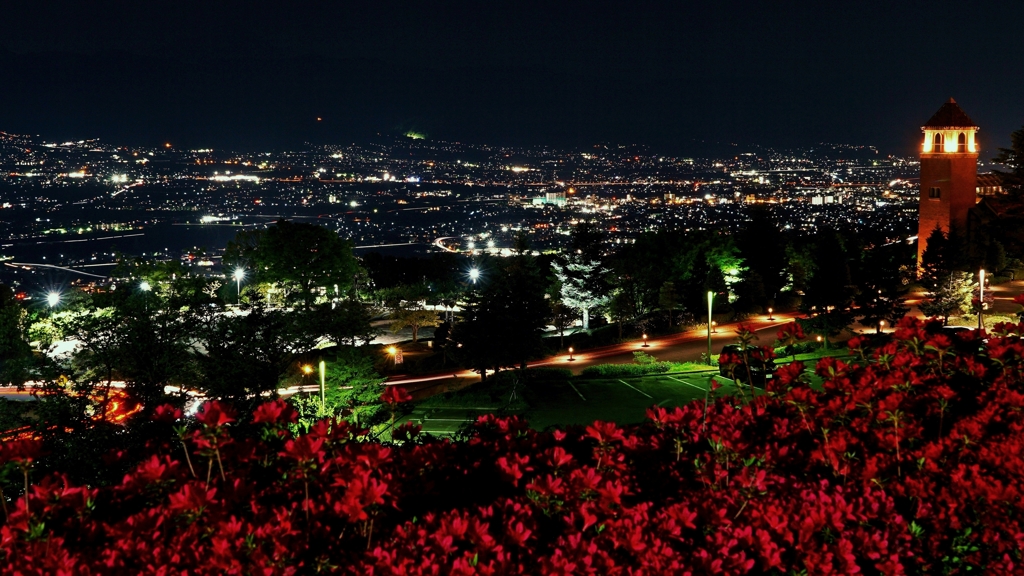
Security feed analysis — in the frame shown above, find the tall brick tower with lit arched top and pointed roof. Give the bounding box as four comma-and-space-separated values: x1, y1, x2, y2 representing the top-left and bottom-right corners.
918, 98, 978, 268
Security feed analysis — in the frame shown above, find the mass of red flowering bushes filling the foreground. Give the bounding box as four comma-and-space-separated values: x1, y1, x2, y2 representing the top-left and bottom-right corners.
0, 319, 1024, 575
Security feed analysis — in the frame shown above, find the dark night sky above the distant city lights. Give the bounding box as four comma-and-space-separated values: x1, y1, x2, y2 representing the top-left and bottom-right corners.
0, 0, 1024, 156
